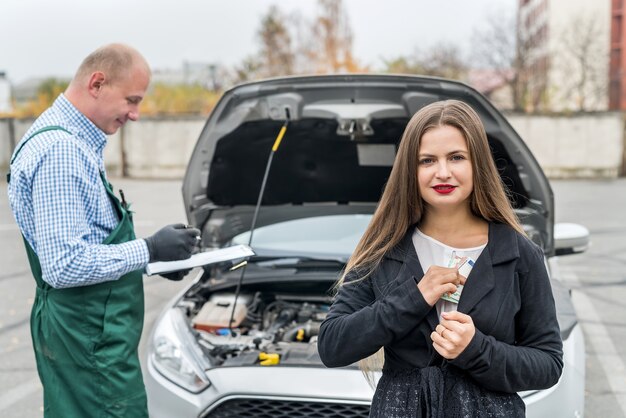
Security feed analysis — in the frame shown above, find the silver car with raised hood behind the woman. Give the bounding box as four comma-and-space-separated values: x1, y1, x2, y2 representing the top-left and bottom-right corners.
145, 75, 588, 418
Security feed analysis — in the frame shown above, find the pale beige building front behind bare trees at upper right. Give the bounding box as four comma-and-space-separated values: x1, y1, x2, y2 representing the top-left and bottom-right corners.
518, 0, 608, 112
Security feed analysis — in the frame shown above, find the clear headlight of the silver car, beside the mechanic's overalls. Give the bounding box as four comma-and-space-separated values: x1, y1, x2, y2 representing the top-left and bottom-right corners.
150, 308, 211, 393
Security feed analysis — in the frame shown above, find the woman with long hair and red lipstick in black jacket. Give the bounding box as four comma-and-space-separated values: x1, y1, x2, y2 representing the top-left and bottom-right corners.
318, 100, 563, 418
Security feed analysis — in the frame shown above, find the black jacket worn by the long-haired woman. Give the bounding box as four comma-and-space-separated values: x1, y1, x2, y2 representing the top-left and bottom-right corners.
318, 223, 563, 393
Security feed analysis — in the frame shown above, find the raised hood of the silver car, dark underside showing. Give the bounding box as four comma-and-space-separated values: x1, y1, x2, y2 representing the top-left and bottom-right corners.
183, 75, 554, 254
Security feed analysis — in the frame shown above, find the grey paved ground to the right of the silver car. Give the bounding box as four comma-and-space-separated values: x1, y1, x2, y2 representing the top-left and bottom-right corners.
553, 179, 626, 418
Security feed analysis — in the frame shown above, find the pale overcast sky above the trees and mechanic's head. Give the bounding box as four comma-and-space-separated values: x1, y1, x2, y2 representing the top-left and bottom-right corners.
0, 0, 517, 84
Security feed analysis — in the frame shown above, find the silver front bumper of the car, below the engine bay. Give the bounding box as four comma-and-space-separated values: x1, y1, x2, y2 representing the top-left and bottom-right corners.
145, 325, 585, 418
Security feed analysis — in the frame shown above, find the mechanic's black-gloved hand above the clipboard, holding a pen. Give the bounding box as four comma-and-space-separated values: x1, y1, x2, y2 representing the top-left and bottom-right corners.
145, 224, 200, 263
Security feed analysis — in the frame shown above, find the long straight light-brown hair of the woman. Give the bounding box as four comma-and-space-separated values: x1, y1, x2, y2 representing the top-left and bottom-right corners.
337, 100, 524, 383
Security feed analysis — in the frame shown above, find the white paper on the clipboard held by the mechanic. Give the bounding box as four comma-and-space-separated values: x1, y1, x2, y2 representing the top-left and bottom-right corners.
146, 244, 254, 276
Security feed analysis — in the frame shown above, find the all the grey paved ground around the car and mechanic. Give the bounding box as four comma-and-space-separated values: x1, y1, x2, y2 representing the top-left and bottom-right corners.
0, 179, 626, 418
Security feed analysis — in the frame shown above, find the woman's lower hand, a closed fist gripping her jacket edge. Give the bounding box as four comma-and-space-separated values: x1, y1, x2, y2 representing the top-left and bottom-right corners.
430, 311, 476, 360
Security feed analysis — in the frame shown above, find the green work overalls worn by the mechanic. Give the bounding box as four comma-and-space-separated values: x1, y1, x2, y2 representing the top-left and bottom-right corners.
14, 126, 148, 418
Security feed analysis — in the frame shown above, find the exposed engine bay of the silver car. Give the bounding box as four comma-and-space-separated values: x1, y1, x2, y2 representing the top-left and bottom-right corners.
177, 289, 331, 367
